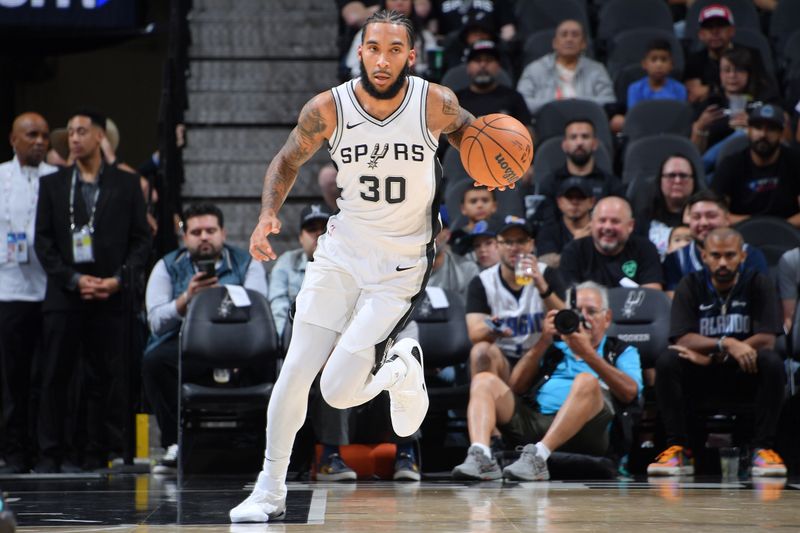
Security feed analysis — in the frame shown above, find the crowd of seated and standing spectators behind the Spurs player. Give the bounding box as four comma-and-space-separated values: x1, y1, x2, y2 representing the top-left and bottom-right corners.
0, 0, 800, 480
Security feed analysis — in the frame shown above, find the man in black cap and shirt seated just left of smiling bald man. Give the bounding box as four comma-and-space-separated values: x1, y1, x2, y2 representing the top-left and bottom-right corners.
536, 177, 596, 268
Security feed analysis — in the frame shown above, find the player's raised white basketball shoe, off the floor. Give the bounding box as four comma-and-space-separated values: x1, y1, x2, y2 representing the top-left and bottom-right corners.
387, 338, 429, 437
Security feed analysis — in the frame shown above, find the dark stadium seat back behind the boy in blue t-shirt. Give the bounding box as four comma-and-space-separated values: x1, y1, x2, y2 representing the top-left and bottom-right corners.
606, 28, 684, 80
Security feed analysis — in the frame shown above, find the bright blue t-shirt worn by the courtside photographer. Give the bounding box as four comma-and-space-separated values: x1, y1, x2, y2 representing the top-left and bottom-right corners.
536, 337, 643, 415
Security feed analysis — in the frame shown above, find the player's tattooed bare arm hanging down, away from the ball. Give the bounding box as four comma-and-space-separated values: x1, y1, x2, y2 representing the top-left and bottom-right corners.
261, 100, 326, 213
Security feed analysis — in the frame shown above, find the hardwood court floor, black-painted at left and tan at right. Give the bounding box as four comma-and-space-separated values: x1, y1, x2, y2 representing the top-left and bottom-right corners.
0, 475, 800, 533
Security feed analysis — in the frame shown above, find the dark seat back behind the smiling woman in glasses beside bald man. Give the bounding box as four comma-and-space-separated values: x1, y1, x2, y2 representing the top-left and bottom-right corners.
622, 133, 706, 183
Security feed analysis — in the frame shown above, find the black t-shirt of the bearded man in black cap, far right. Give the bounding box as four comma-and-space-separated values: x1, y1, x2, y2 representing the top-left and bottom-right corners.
712, 146, 800, 218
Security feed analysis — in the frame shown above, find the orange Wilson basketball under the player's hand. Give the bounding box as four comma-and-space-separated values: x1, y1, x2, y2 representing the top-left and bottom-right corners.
461, 113, 533, 187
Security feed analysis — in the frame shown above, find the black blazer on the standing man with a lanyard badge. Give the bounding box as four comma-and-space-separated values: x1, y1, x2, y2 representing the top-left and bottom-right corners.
34, 166, 151, 311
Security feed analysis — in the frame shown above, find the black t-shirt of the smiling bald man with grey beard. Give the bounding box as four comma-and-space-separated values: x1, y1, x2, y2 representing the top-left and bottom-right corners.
559, 234, 664, 287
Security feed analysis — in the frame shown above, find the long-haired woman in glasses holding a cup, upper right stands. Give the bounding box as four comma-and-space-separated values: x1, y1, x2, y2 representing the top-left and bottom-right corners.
692, 48, 776, 170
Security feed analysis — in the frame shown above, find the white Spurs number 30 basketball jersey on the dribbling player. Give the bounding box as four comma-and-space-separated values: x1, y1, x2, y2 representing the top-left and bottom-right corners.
328, 76, 441, 255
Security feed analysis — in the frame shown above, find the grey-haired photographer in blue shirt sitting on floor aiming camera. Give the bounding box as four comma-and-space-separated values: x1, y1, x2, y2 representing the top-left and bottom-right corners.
453, 282, 642, 481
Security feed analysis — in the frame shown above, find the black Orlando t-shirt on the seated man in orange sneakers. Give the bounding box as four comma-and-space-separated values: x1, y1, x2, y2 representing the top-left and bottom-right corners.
669, 269, 783, 342
